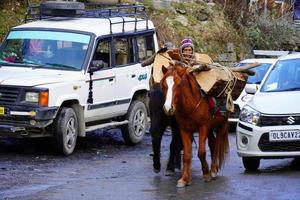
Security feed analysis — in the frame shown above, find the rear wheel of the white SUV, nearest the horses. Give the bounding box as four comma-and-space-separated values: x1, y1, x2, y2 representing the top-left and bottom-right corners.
121, 100, 147, 145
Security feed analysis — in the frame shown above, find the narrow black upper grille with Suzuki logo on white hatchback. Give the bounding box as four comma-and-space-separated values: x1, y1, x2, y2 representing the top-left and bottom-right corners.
259, 115, 300, 126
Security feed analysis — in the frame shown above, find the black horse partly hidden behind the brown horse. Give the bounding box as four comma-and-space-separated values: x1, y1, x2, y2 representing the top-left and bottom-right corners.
148, 84, 182, 176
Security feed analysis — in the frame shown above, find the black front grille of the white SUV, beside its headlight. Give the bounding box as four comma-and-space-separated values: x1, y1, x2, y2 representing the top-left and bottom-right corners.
0, 86, 20, 105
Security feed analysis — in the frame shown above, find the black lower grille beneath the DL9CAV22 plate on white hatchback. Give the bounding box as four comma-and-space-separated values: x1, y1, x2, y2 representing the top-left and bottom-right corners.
258, 133, 300, 152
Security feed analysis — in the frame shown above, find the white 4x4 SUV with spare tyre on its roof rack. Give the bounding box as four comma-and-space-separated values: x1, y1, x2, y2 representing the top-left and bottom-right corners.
0, 1, 158, 155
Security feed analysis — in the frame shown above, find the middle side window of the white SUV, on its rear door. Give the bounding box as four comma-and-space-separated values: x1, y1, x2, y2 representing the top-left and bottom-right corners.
114, 38, 134, 66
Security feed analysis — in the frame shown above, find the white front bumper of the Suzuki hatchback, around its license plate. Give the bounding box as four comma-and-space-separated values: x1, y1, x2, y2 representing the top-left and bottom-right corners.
236, 122, 300, 158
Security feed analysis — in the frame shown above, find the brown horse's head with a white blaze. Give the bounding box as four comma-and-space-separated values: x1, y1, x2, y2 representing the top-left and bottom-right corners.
160, 64, 187, 115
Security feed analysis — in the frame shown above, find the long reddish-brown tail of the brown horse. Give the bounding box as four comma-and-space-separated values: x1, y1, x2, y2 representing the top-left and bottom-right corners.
215, 121, 229, 168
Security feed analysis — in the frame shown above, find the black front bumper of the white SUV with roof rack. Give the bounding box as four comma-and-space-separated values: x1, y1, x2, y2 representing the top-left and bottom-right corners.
0, 106, 58, 137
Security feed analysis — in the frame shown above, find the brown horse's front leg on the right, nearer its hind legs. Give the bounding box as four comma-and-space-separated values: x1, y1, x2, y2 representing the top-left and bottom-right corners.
198, 125, 210, 182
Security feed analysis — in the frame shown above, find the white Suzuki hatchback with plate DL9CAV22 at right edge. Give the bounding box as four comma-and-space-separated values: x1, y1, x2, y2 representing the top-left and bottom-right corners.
236, 54, 300, 170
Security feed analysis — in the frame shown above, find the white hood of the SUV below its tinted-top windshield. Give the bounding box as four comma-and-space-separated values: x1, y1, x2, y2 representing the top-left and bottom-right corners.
0, 67, 81, 86
